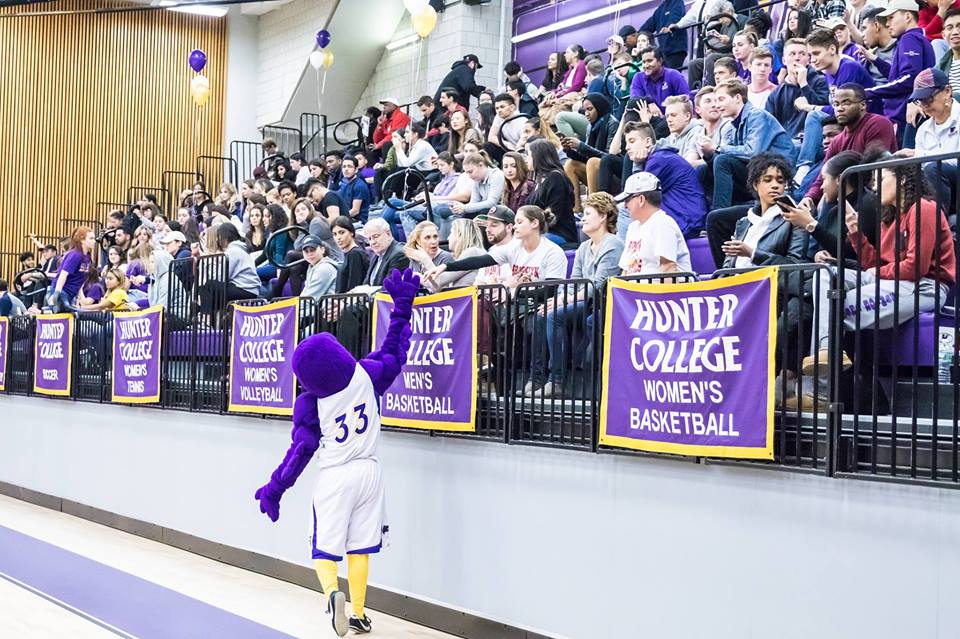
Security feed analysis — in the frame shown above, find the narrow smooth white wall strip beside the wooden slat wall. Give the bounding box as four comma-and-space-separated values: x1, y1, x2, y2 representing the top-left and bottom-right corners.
223, 6, 260, 151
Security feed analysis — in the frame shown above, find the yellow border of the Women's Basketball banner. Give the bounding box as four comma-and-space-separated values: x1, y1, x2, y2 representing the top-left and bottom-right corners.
598, 266, 780, 460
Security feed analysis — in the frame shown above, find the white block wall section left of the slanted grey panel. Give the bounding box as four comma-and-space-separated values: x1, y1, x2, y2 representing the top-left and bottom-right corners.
256, 0, 337, 127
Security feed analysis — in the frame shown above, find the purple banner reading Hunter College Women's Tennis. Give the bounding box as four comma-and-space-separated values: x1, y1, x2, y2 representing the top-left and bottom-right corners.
113, 306, 163, 404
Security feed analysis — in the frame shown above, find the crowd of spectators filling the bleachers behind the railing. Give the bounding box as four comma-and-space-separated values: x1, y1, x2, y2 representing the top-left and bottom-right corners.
7, 0, 960, 406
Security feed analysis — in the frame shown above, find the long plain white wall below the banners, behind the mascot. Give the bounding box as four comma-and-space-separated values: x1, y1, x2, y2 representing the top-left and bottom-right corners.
0, 396, 960, 639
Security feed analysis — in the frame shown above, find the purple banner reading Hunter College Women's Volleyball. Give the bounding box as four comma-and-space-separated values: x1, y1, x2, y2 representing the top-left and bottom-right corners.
228, 298, 300, 415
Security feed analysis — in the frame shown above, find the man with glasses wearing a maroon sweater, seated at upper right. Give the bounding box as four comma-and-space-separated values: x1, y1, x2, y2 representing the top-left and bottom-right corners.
800, 83, 897, 211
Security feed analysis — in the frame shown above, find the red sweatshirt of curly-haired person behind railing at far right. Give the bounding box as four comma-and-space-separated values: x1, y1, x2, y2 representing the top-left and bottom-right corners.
848, 200, 957, 286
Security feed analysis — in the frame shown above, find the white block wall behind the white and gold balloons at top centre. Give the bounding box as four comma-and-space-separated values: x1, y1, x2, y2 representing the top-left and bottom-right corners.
354, 0, 513, 119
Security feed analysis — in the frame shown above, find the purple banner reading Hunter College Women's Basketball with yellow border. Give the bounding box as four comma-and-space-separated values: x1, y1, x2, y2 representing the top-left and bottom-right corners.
600, 268, 777, 459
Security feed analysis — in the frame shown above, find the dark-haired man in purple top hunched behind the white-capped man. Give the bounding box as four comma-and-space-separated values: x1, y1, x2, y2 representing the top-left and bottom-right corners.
619, 122, 707, 239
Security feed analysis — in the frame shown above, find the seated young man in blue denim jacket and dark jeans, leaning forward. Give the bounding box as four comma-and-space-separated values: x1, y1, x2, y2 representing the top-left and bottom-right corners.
700, 80, 793, 209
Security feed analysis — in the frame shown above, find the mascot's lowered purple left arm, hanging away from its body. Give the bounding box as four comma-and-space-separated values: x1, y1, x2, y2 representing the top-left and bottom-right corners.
254, 393, 320, 521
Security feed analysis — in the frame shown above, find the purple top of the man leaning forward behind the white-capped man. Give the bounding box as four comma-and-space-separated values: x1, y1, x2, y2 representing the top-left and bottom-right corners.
634, 147, 707, 238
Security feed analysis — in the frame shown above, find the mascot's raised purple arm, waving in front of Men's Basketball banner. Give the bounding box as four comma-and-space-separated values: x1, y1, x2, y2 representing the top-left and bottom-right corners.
360, 269, 420, 395
